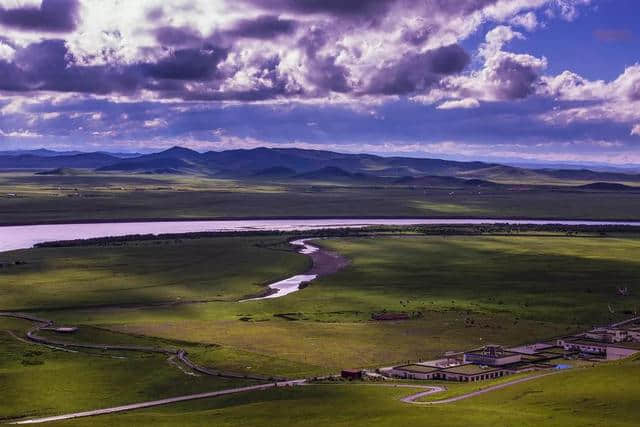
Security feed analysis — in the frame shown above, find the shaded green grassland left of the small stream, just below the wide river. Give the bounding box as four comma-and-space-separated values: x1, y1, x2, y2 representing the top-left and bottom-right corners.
0, 237, 309, 311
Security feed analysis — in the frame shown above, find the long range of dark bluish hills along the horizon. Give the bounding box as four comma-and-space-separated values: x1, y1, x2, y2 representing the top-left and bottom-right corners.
0, 147, 640, 185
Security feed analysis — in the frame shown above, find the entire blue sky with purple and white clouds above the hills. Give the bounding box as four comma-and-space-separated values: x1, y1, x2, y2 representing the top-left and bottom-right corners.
0, 0, 640, 165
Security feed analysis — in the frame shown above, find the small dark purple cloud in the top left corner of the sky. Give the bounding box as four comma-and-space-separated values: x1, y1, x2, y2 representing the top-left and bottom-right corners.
0, 0, 78, 32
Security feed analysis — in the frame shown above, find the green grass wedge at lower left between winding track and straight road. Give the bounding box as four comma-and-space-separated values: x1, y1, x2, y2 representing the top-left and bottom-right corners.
0, 318, 248, 422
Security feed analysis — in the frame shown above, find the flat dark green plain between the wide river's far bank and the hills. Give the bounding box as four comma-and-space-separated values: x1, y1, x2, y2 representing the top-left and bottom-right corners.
0, 172, 640, 224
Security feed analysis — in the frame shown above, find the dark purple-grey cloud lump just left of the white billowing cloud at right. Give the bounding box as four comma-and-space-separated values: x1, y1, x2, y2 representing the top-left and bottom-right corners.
367, 44, 470, 95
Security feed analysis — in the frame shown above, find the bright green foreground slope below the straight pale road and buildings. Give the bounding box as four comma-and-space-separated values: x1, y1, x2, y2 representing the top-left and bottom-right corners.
51, 361, 640, 427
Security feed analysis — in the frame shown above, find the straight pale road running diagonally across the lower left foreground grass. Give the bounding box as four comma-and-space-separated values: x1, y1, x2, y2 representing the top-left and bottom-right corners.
11, 380, 305, 424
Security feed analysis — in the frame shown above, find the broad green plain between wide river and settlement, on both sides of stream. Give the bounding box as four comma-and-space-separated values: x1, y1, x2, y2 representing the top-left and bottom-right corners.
0, 236, 640, 376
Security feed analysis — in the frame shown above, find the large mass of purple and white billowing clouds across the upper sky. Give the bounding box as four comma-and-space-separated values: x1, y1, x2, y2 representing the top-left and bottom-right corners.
0, 0, 582, 105
